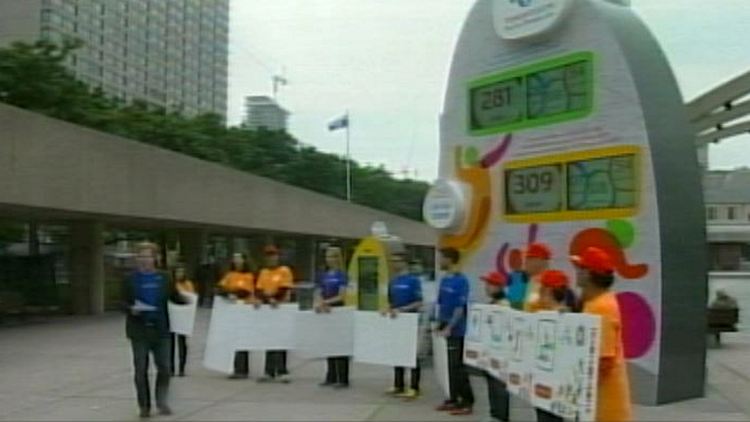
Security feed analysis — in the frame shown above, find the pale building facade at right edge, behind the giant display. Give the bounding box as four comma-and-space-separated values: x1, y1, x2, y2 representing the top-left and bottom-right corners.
704, 168, 750, 271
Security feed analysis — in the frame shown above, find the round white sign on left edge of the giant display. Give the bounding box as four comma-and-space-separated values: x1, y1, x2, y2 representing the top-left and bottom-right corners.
422, 179, 466, 230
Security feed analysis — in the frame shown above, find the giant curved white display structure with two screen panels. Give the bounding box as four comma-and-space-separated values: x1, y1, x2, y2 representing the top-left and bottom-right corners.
424, 0, 706, 404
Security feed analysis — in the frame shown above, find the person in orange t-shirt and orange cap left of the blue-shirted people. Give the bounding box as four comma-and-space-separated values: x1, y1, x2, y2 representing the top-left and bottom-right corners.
255, 245, 294, 383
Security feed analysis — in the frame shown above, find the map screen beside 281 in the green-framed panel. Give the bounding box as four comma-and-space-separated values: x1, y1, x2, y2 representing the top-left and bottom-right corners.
526, 61, 591, 119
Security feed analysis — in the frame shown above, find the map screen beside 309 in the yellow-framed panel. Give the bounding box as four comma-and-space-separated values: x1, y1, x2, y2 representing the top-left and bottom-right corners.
567, 155, 638, 211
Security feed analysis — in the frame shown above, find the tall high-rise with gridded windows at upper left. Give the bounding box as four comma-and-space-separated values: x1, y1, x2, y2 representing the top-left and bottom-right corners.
0, 0, 229, 116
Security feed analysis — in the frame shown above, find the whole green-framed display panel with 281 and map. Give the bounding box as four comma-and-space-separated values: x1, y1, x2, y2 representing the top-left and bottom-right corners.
468, 52, 594, 135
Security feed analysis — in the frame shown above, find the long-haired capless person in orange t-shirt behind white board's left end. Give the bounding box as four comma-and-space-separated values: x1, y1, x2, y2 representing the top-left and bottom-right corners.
219, 253, 255, 379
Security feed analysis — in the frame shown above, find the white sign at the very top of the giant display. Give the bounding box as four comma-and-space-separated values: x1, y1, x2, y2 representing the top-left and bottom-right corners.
492, 0, 575, 40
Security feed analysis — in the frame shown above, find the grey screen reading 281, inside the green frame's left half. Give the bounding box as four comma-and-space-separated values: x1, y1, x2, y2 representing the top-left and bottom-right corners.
471, 77, 526, 130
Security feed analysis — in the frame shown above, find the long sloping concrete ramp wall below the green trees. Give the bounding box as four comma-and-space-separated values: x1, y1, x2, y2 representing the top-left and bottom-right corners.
0, 105, 435, 245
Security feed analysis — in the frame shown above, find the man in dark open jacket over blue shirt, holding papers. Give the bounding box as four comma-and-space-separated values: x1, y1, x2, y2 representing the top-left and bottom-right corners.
122, 243, 188, 418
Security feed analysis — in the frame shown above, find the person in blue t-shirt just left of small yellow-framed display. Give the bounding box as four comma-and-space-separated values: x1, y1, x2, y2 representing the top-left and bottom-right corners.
315, 246, 349, 389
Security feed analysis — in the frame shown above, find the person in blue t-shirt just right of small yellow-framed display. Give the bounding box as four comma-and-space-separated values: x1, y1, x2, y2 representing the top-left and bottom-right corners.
385, 253, 422, 400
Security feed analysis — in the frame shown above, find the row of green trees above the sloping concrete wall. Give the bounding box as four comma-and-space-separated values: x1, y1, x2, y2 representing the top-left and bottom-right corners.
0, 40, 428, 220
